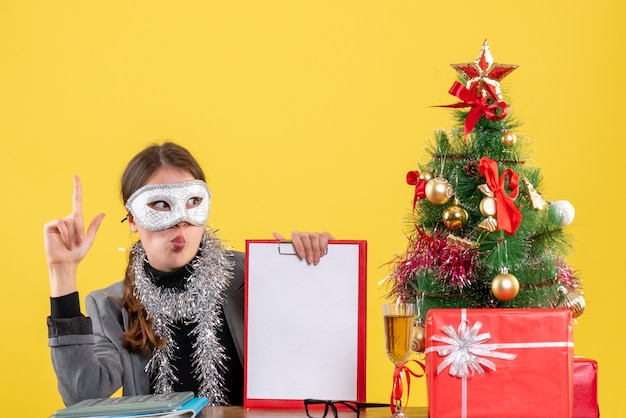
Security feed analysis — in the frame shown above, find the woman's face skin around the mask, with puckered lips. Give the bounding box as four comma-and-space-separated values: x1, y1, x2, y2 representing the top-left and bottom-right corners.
128, 166, 204, 271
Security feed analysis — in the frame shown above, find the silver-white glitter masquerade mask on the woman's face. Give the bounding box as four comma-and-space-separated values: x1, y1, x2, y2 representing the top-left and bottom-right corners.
126, 180, 211, 232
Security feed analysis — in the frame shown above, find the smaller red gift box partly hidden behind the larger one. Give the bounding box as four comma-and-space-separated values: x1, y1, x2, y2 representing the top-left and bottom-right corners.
572, 357, 600, 418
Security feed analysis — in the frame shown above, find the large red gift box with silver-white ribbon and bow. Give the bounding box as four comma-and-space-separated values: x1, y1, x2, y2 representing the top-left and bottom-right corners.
425, 309, 574, 418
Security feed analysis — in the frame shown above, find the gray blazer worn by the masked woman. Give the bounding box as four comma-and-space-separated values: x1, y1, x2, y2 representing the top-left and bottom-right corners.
48, 252, 245, 405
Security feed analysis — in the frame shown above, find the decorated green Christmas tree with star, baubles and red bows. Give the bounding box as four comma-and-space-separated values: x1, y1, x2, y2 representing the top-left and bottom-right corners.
388, 41, 585, 334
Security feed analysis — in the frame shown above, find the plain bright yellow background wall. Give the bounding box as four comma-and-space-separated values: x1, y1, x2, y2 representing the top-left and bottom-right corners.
0, 0, 626, 418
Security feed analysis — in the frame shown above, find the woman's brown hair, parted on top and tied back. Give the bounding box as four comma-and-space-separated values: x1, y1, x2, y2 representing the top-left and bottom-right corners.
121, 142, 205, 356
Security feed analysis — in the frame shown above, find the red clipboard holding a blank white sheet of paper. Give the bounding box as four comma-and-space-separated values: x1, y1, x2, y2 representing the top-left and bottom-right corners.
244, 240, 367, 409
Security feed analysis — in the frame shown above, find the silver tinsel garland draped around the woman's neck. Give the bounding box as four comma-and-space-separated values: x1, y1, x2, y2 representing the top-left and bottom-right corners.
131, 229, 233, 405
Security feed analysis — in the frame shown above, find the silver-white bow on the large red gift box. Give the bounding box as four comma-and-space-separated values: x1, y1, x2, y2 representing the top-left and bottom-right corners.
429, 320, 517, 378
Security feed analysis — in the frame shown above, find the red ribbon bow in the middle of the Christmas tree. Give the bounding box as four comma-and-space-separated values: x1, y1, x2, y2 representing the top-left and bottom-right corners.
479, 157, 522, 235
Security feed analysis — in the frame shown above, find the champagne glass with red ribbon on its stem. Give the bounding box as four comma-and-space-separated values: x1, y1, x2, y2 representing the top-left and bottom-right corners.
383, 303, 415, 418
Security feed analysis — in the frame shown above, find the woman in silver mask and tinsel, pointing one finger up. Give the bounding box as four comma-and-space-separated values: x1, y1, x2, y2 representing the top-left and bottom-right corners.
44, 142, 334, 405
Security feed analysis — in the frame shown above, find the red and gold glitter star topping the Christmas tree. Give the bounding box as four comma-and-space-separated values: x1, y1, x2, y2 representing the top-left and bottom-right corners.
451, 39, 518, 102
